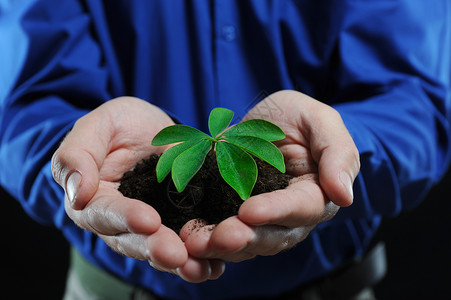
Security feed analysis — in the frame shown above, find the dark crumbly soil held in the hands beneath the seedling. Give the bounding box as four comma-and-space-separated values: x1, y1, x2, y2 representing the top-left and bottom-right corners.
119, 152, 292, 232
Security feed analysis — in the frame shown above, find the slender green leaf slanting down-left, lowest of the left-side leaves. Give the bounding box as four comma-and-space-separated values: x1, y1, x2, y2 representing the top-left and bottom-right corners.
171, 140, 212, 193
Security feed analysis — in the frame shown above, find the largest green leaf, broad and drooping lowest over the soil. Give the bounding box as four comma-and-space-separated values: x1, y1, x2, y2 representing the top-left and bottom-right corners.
216, 141, 257, 200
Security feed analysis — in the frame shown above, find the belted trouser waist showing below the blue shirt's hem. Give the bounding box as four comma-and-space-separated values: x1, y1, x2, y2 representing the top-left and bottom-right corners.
71, 242, 387, 300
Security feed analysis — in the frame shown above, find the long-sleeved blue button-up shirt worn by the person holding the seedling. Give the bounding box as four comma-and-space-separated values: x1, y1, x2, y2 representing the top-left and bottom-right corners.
0, 0, 451, 299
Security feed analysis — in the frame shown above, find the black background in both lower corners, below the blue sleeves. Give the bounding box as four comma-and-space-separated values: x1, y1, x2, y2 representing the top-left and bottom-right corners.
0, 173, 451, 300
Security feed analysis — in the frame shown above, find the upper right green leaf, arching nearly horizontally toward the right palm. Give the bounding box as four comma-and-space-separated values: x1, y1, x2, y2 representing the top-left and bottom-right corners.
224, 119, 285, 142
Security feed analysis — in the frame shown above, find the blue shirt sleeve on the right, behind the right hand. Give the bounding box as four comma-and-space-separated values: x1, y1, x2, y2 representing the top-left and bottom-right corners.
335, 1, 451, 221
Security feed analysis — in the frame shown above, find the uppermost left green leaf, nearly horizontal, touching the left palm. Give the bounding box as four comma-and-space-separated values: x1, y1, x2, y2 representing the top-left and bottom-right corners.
152, 124, 210, 146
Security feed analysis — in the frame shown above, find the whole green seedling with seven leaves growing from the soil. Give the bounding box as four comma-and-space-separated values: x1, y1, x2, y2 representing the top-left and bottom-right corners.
152, 107, 285, 200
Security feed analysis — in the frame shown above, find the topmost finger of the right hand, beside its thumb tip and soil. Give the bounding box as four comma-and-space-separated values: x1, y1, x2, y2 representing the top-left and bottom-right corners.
238, 175, 338, 228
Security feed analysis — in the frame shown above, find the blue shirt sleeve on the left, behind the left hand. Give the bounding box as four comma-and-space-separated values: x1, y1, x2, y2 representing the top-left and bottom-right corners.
0, 1, 107, 227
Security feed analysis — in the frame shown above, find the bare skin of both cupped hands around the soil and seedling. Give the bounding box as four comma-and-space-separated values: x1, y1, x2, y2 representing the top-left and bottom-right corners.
52, 91, 360, 282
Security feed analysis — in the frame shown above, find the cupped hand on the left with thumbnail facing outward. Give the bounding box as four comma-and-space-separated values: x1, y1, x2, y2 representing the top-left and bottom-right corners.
52, 97, 224, 282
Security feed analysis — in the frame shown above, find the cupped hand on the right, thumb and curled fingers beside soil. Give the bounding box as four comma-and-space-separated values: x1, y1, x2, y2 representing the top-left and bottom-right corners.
181, 91, 360, 262
